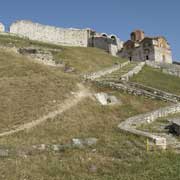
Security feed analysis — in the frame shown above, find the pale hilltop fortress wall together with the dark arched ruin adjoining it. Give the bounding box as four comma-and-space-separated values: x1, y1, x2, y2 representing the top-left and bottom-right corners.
10, 20, 123, 56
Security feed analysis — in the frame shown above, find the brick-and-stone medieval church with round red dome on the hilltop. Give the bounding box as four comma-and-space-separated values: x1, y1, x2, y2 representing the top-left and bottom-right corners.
118, 30, 172, 63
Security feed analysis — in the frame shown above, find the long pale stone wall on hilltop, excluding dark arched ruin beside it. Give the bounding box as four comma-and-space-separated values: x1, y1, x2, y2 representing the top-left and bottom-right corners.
10, 20, 90, 47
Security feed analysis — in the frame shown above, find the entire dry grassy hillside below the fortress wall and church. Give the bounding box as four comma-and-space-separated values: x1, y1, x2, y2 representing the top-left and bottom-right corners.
0, 35, 180, 180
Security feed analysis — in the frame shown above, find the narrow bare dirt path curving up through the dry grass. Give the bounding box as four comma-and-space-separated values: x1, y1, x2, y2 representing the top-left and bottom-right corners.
0, 84, 91, 137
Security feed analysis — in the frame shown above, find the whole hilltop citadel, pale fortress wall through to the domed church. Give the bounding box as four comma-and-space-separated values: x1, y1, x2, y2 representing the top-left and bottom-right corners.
0, 20, 172, 63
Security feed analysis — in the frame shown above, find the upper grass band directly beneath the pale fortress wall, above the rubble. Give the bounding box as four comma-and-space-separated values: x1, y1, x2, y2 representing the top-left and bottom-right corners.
0, 35, 125, 74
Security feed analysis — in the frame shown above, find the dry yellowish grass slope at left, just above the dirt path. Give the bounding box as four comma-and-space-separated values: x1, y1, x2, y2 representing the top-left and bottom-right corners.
0, 51, 78, 130
